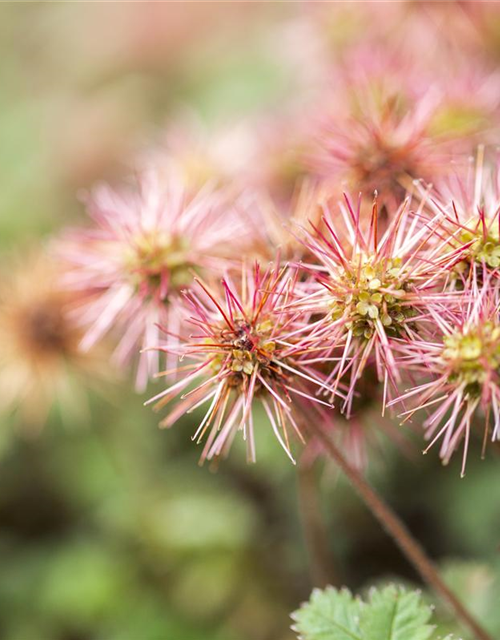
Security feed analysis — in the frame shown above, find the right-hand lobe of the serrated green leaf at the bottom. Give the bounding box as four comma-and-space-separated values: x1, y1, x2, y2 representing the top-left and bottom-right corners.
360, 585, 433, 640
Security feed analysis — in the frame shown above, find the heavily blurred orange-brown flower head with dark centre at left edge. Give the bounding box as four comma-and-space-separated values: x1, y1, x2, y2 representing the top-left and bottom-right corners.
0, 252, 112, 432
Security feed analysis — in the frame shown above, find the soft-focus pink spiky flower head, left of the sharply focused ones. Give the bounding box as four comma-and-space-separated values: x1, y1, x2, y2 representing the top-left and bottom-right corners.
58, 170, 244, 390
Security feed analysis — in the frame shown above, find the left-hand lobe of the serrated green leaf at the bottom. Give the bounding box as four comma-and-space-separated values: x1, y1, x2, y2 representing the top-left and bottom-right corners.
292, 587, 363, 640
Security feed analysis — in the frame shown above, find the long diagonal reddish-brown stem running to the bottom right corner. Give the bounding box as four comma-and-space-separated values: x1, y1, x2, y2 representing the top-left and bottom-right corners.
308, 420, 493, 640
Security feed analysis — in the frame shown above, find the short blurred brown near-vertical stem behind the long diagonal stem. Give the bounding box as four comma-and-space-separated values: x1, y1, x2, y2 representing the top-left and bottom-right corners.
297, 459, 338, 587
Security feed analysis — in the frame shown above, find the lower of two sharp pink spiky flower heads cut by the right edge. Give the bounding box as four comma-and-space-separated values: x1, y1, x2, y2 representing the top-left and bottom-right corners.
395, 272, 500, 475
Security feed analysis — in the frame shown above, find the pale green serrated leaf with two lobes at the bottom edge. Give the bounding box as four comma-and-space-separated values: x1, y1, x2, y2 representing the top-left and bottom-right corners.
292, 585, 434, 640
